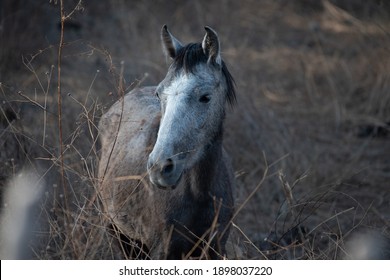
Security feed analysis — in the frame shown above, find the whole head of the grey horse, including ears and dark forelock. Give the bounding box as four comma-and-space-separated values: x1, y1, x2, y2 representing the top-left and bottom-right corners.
147, 26, 227, 188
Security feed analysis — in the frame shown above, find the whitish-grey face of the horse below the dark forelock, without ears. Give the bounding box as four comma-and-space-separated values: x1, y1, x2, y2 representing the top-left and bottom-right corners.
148, 64, 225, 187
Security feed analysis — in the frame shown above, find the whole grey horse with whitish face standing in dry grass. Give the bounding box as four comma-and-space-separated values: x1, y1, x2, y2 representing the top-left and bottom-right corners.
98, 25, 236, 259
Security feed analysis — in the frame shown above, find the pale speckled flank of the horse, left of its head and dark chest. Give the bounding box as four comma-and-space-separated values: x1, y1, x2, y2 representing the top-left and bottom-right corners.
98, 87, 160, 243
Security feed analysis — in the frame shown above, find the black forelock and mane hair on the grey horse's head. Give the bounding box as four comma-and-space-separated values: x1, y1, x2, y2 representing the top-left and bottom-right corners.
172, 43, 236, 106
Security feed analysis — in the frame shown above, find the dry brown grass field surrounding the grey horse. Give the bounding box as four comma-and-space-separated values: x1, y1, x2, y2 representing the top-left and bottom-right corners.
0, 0, 390, 259
